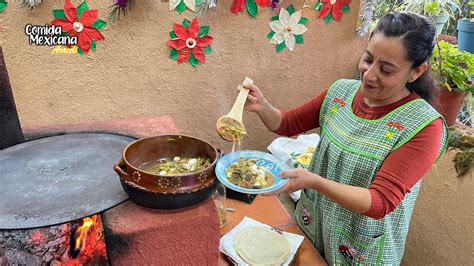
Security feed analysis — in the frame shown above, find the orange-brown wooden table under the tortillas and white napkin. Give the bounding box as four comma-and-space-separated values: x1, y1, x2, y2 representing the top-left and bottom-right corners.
219, 195, 327, 266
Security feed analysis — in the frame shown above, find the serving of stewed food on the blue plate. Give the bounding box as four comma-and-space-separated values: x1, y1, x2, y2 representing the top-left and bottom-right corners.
226, 158, 275, 189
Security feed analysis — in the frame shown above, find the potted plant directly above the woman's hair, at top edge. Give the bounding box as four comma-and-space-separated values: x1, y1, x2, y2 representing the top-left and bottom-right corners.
397, 0, 459, 35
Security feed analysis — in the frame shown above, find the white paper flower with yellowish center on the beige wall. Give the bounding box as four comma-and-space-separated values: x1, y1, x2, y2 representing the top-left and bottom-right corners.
268, 8, 308, 51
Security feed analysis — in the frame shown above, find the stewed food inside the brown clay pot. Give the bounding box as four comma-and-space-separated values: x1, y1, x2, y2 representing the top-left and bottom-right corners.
139, 157, 211, 176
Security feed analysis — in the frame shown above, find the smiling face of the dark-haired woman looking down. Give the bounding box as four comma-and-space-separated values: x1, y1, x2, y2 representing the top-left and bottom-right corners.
359, 33, 414, 106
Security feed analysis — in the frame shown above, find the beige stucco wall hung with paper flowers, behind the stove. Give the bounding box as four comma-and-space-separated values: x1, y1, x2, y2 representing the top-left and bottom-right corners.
0, 0, 366, 149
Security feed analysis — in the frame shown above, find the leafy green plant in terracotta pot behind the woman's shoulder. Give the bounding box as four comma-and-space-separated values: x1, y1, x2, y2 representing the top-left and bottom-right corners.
430, 41, 474, 125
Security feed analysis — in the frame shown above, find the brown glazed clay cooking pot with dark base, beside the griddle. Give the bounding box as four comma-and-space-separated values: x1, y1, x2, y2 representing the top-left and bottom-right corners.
114, 135, 219, 209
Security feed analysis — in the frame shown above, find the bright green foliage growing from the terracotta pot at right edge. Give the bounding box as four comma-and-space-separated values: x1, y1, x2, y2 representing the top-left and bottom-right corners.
430, 41, 474, 92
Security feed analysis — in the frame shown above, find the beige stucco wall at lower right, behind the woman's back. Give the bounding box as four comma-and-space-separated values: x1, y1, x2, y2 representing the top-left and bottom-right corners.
403, 151, 474, 265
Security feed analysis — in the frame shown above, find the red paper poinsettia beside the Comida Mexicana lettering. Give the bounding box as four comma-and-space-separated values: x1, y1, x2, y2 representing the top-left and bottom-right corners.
49, 0, 105, 54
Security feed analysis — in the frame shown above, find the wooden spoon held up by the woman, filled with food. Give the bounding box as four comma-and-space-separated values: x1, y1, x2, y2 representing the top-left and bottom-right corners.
216, 77, 253, 142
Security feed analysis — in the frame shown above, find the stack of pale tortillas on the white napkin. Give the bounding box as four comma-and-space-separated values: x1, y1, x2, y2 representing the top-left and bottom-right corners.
234, 227, 291, 265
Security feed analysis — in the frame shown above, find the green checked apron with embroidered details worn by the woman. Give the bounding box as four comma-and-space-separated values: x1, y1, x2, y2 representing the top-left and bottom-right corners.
295, 80, 448, 265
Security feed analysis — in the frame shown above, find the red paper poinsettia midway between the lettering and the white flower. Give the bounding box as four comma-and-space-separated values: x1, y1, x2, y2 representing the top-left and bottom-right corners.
166, 19, 212, 66
